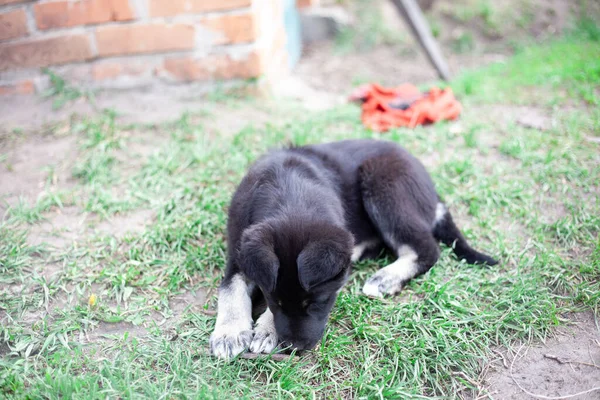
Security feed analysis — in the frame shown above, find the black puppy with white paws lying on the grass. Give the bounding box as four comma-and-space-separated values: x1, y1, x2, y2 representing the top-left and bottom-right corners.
210, 140, 496, 358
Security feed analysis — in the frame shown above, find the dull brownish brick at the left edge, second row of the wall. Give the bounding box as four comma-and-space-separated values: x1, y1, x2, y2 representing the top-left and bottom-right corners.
0, 34, 93, 71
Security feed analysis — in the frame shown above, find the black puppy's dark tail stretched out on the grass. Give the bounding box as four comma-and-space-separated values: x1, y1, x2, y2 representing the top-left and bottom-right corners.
433, 208, 498, 265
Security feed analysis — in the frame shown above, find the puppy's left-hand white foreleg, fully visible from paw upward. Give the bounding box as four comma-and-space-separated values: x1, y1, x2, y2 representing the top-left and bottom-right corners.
209, 275, 252, 360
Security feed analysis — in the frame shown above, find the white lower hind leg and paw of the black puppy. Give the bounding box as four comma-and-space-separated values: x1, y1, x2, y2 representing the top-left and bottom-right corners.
363, 245, 419, 297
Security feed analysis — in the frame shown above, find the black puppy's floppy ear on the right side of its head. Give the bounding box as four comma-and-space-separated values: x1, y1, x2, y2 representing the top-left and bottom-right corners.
296, 231, 352, 292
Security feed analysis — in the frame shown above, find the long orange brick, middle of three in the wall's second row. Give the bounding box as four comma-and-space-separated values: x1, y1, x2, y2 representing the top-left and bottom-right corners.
96, 24, 194, 57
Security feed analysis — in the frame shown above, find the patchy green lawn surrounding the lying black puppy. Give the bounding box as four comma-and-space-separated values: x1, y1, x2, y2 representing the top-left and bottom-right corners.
0, 31, 600, 399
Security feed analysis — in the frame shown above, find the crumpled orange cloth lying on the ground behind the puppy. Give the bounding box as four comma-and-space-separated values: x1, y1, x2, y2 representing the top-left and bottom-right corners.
350, 83, 462, 132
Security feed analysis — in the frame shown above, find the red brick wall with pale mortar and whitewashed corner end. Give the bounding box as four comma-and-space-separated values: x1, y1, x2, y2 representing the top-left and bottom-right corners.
0, 0, 287, 94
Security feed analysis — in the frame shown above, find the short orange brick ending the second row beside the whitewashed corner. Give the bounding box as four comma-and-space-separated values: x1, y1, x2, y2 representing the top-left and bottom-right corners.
201, 14, 257, 44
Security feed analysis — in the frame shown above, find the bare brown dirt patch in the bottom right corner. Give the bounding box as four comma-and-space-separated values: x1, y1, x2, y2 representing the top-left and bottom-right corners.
485, 312, 600, 400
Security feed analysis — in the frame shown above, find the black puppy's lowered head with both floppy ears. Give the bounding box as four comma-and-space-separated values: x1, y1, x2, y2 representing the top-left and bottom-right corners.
240, 220, 353, 350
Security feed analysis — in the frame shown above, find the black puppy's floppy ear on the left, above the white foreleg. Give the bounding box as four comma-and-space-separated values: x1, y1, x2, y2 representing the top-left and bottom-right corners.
239, 224, 279, 292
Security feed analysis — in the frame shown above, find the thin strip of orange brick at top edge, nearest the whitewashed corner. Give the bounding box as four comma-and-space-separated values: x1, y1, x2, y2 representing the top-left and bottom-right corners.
149, 0, 252, 17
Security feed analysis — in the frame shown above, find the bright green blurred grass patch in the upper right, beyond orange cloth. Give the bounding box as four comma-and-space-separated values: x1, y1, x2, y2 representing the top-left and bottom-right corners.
452, 20, 600, 106
